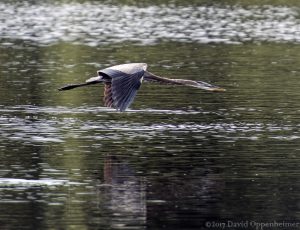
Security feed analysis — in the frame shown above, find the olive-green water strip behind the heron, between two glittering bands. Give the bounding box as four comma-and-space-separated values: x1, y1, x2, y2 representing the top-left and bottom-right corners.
0, 40, 299, 118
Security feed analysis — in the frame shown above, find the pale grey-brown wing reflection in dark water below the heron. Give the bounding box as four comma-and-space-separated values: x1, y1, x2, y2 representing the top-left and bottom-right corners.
98, 155, 146, 227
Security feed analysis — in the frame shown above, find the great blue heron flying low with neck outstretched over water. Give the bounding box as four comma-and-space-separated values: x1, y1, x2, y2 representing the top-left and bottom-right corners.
59, 63, 225, 111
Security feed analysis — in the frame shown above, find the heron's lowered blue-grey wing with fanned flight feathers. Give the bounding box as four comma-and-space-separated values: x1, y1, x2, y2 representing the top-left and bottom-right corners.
101, 69, 144, 111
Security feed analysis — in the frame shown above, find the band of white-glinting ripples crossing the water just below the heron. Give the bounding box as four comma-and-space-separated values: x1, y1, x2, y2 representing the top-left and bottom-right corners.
0, 105, 300, 144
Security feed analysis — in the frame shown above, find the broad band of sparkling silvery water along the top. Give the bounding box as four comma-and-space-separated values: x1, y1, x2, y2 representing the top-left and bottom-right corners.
0, 2, 300, 46
